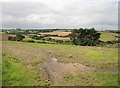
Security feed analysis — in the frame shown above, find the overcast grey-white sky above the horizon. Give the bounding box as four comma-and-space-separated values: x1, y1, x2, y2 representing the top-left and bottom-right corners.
0, 0, 119, 29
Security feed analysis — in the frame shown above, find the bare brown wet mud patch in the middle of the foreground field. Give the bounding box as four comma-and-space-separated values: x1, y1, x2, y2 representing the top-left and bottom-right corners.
43, 58, 94, 84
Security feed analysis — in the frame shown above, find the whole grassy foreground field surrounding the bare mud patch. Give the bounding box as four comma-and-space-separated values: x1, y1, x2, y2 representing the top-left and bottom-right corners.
2, 41, 118, 86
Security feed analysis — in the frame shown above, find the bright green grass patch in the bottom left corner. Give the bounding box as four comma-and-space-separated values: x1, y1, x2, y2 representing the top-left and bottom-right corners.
2, 55, 36, 86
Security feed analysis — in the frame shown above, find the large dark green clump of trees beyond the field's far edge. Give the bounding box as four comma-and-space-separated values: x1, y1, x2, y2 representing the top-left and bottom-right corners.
70, 28, 101, 46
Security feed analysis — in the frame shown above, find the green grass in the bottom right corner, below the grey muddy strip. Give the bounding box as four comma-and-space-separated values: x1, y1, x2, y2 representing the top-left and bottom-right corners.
90, 72, 118, 86
